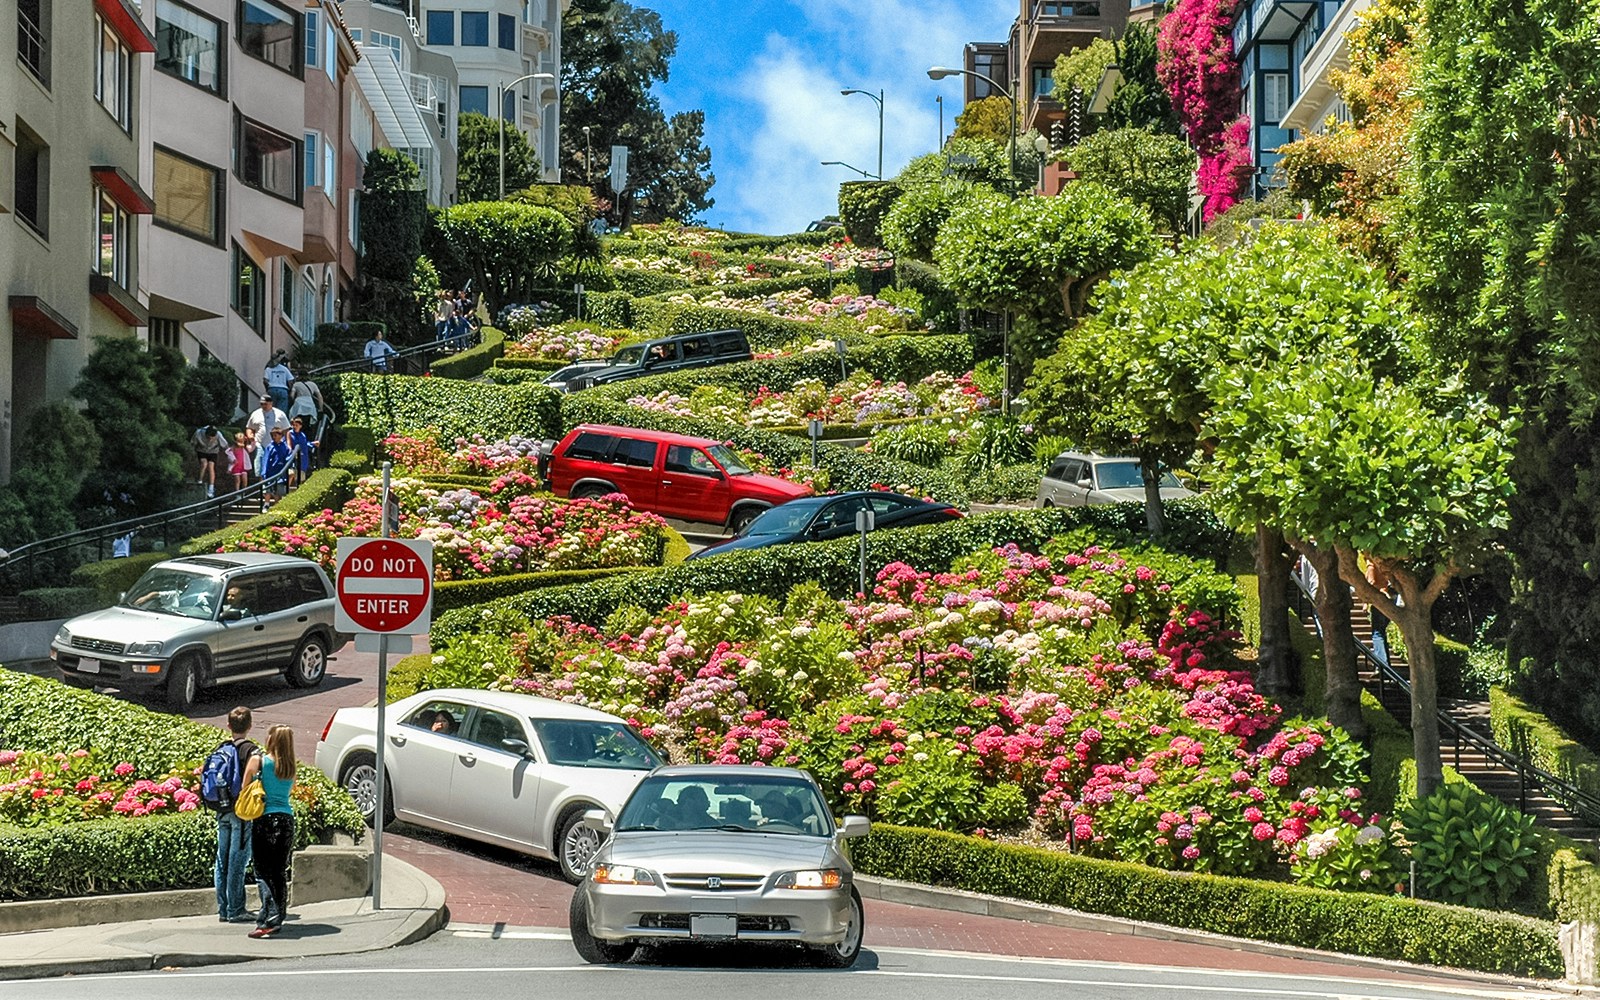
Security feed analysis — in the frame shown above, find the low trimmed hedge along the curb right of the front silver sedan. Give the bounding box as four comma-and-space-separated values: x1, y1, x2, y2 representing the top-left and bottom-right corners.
851, 826, 1565, 978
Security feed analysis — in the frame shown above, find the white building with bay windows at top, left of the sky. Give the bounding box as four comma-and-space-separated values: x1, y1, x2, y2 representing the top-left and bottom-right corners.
418, 0, 571, 182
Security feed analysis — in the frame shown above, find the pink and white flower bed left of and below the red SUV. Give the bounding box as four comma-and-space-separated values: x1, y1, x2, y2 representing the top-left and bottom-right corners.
222, 472, 666, 581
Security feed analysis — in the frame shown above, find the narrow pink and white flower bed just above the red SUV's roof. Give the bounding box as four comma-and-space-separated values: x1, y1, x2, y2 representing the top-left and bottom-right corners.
627, 371, 992, 427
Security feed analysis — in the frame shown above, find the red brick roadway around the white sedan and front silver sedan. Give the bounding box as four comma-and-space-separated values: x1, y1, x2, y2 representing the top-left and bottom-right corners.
190, 646, 1491, 986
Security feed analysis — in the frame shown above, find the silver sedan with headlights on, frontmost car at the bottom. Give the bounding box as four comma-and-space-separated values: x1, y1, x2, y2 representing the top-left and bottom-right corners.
571, 765, 869, 968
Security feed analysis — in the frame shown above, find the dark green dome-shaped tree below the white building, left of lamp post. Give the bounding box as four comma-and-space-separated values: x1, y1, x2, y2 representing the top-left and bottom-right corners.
437, 202, 573, 314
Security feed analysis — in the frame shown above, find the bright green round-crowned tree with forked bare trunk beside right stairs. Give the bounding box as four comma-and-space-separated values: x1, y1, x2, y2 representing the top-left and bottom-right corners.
1211, 354, 1515, 798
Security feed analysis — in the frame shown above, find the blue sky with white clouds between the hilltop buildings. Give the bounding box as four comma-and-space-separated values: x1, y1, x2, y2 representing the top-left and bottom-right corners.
634, 0, 1018, 234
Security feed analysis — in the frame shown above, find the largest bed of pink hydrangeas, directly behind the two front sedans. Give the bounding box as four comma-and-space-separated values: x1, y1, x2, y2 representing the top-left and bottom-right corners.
419, 546, 1392, 890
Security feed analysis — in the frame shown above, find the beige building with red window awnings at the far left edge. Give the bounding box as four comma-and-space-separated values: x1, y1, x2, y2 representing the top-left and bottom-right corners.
0, 0, 155, 480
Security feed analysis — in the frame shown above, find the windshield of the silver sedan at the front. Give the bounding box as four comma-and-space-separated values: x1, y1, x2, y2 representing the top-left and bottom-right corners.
616, 774, 834, 837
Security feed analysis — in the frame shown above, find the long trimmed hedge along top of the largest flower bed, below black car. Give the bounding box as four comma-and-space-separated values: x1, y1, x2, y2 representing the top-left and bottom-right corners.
430, 502, 1214, 650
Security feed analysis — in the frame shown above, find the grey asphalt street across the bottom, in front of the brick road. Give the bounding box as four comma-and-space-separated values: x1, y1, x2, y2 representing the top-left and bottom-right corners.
0, 930, 1558, 1000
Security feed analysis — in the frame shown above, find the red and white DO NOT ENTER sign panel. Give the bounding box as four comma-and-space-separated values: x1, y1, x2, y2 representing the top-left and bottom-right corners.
333, 538, 434, 635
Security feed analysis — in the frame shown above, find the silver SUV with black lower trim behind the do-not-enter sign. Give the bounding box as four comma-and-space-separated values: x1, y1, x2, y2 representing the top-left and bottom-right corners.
50, 552, 349, 710
